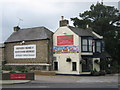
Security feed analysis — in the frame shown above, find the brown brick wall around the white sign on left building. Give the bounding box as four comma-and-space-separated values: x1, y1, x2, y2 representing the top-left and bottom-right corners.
5, 40, 52, 63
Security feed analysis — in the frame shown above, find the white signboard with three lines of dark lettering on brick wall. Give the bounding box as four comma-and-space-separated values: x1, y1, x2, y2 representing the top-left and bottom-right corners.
14, 45, 36, 59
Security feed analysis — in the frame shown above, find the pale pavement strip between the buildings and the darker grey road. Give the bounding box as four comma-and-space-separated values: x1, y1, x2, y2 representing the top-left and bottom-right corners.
0, 74, 118, 85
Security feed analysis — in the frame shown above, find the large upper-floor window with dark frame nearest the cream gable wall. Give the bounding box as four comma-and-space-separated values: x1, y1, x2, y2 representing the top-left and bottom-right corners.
82, 37, 92, 52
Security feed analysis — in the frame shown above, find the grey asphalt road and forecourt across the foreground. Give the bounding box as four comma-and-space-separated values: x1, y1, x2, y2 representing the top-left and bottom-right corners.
2, 75, 119, 88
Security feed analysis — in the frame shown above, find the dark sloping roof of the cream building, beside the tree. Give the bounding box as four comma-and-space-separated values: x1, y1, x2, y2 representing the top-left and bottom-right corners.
68, 26, 98, 39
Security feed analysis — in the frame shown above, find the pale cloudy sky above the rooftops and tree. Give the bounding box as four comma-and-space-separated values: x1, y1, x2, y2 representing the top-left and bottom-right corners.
0, 0, 119, 43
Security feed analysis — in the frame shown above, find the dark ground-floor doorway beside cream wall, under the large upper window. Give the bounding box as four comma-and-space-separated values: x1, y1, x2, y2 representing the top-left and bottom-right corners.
82, 57, 92, 72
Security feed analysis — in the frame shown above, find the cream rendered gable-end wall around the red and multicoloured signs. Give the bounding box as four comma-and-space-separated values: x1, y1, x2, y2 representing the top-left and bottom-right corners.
53, 26, 80, 74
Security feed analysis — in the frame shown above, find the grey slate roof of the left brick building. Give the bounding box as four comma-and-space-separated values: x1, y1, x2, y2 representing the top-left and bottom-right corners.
5, 27, 53, 43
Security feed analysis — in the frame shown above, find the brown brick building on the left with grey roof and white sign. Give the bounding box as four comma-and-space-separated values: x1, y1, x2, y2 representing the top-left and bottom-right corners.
4, 26, 53, 71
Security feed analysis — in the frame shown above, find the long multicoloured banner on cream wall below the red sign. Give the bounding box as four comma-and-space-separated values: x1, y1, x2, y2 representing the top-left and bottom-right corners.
53, 46, 79, 53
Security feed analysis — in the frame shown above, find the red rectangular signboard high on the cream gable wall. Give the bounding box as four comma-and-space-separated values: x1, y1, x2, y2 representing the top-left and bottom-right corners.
57, 35, 74, 45
